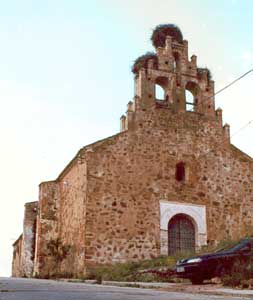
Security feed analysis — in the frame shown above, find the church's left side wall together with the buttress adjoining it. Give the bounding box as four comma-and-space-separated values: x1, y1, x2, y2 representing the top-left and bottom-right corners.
34, 157, 86, 277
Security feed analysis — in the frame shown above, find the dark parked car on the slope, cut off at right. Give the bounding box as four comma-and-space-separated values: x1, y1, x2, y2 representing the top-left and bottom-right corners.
176, 238, 253, 284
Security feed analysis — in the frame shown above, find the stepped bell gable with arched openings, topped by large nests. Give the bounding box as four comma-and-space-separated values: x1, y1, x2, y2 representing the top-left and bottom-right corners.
121, 24, 217, 130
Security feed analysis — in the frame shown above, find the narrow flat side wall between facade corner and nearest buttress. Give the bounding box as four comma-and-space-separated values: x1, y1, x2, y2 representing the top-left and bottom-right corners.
59, 156, 87, 276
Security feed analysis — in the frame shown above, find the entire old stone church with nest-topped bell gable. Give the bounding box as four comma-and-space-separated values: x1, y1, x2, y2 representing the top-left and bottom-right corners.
13, 24, 253, 277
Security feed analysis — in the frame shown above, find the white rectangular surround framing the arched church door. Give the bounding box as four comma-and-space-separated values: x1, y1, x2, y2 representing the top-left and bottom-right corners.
160, 200, 207, 255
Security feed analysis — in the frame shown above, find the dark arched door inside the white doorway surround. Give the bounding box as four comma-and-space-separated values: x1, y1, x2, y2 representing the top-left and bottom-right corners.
168, 214, 195, 255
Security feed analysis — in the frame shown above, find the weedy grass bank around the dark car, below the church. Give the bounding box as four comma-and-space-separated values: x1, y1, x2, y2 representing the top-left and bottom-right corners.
85, 239, 253, 287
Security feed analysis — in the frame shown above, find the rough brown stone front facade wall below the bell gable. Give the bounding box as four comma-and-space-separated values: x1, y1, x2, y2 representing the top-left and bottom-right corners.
85, 109, 253, 264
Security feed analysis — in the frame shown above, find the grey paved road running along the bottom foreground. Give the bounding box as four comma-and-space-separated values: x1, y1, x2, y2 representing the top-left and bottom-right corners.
0, 278, 252, 300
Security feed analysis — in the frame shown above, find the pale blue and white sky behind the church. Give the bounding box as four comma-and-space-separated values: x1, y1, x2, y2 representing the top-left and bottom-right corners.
0, 0, 253, 275
